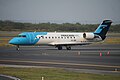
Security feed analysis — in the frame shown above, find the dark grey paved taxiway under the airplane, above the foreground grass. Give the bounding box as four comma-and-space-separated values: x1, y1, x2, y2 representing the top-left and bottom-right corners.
0, 44, 120, 74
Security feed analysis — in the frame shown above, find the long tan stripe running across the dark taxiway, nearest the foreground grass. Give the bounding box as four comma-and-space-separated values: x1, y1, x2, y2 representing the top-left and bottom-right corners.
0, 60, 120, 68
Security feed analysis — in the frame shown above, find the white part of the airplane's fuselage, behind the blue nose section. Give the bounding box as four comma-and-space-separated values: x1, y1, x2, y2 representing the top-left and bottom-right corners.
36, 32, 102, 45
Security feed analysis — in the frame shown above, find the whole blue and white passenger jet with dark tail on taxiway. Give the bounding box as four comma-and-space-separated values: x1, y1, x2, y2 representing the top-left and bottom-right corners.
9, 20, 112, 50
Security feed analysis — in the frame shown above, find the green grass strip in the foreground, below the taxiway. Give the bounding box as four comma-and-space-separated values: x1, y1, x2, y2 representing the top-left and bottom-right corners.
0, 67, 120, 80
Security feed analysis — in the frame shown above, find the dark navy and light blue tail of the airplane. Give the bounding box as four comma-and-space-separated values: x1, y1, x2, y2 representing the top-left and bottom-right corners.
94, 20, 112, 40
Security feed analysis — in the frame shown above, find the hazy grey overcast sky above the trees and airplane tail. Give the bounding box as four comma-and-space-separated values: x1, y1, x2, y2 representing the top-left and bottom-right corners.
0, 0, 120, 23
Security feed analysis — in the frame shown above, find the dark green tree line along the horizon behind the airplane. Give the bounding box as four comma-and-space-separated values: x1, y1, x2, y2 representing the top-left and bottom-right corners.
0, 20, 120, 32
